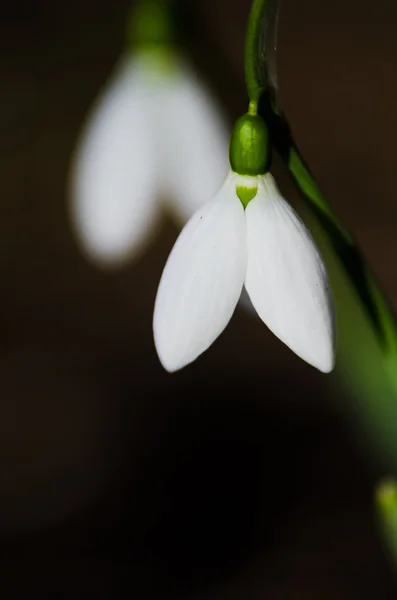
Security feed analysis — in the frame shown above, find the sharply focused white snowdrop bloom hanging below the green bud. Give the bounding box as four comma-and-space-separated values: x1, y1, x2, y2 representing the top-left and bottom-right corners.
153, 171, 334, 373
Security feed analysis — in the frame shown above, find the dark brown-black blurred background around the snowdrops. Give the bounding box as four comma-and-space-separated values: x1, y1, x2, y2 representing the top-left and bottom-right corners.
0, 0, 397, 600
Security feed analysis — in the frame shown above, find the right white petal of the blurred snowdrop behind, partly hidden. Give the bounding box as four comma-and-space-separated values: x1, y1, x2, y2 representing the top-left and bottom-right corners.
156, 63, 230, 224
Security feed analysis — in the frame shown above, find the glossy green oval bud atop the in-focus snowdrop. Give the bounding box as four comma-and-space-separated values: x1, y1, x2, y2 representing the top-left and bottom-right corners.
229, 114, 271, 177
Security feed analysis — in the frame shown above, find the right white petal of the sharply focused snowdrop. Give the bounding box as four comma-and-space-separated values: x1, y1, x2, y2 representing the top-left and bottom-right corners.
245, 174, 334, 373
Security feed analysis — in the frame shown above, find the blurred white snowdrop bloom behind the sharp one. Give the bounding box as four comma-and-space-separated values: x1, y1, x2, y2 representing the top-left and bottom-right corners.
71, 49, 229, 265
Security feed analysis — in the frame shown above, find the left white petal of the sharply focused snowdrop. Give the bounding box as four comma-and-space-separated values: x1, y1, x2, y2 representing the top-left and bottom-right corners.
153, 174, 246, 371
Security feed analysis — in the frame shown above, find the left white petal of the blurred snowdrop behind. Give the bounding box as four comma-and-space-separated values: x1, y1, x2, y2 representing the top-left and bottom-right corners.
71, 56, 160, 264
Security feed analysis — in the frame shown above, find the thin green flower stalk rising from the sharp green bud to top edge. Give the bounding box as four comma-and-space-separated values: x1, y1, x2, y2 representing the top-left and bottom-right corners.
245, 0, 279, 113
